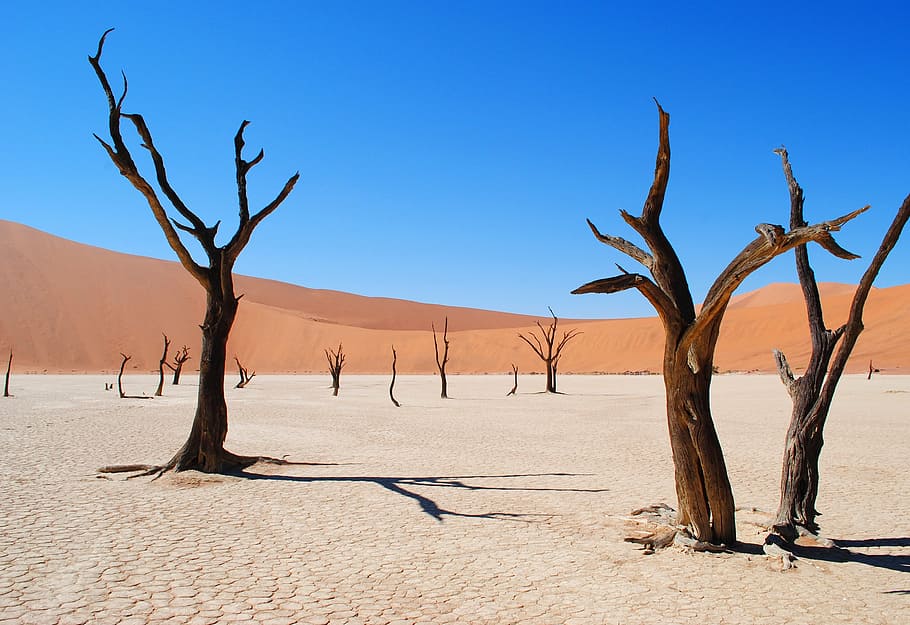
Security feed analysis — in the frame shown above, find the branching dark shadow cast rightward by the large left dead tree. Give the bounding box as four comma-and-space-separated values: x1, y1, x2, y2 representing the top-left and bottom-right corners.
233, 463, 607, 523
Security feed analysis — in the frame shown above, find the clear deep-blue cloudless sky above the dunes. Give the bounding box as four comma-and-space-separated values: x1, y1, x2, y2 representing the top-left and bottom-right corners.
0, 0, 910, 317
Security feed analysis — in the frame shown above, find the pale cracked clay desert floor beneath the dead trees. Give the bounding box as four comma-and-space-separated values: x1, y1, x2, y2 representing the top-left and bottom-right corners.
0, 375, 910, 625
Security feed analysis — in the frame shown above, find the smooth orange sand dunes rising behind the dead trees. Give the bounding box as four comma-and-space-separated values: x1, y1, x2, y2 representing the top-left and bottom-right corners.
0, 220, 910, 373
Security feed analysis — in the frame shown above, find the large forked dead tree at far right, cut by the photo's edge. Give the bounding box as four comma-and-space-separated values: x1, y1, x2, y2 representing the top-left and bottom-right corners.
772, 148, 910, 541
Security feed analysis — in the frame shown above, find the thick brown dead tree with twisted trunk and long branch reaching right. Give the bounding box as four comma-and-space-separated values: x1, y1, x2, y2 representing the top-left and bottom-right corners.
572, 104, 868, 545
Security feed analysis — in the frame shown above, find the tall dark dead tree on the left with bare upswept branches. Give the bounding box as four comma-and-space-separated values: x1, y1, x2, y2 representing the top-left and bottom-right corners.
89, 31, 299, 474
